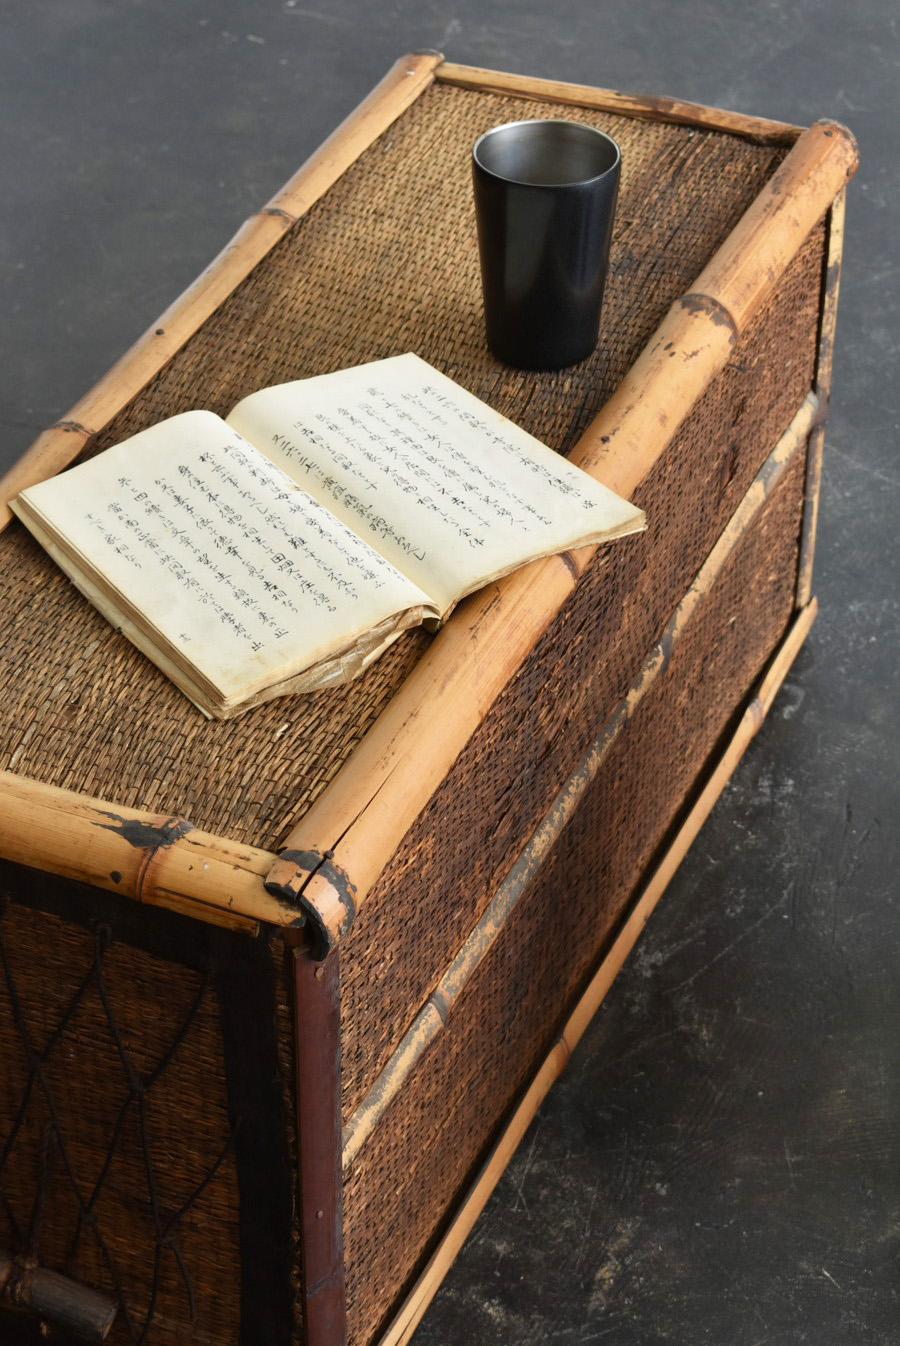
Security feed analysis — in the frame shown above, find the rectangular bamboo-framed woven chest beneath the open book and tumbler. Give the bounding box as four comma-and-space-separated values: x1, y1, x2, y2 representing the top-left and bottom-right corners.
0, 54, 856, 1346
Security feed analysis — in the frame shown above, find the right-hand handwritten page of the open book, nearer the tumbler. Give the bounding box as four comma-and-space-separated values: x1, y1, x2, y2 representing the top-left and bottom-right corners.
227, 354, 643, 612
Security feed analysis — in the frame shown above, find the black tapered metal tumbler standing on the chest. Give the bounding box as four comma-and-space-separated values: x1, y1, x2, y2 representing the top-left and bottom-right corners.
472, 120, 620, 369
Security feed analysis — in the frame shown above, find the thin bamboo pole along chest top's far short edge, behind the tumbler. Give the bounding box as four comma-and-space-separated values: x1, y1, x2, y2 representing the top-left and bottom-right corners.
435, 61, 803, 145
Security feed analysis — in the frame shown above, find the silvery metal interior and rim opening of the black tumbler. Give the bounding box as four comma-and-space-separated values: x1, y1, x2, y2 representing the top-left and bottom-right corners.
472, 118, 619, 187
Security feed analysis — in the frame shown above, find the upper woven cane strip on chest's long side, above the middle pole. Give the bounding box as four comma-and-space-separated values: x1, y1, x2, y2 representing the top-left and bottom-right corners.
334, 230, 822, 1116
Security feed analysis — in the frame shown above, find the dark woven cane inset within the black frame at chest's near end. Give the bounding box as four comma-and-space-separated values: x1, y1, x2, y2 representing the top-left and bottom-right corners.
0, 895, 241, 1346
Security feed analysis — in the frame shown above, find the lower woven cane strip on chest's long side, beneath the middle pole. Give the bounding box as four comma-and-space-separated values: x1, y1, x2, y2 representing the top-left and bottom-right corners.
344, 455, 804, 1346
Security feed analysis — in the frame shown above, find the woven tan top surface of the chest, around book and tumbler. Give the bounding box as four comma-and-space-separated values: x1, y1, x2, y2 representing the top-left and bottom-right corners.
0, 86, 784, 847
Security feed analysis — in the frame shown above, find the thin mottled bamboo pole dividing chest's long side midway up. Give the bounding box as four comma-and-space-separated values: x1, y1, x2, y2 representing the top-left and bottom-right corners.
343, 393, 818, 1170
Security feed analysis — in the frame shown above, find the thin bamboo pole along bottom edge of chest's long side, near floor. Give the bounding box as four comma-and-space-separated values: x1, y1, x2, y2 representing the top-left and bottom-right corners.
378, 599, 817, 1346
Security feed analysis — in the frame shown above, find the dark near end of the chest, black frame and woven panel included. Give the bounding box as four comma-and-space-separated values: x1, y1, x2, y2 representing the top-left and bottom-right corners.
0, 864, 292, 1346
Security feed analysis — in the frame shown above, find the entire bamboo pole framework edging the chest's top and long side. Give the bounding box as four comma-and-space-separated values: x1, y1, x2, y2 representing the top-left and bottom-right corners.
0, 60, 857, 1346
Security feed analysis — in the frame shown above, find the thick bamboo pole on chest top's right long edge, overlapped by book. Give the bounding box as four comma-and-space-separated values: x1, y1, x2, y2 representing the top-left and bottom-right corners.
268, 115, 857, 957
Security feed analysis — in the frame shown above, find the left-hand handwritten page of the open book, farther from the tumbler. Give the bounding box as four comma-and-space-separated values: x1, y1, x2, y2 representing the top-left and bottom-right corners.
15, 412, 433, 701
